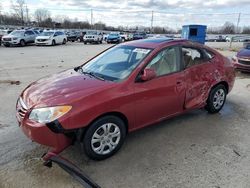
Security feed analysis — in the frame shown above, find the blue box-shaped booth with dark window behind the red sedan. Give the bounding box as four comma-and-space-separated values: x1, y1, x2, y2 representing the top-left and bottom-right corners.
182, 25, 207, 44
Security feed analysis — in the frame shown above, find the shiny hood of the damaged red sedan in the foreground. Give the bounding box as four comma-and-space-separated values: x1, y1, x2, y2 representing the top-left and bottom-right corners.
21, 69, 115, 108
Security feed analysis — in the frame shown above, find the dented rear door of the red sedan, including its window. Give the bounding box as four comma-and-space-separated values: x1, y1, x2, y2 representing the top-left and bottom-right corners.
182, 45, 216, 109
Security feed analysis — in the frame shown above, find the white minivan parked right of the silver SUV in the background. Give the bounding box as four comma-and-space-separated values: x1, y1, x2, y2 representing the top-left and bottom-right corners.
35, 31, 67, 46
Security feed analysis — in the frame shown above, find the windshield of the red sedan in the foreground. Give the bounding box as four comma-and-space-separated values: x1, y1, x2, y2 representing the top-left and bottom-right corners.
82, 46, 151, 81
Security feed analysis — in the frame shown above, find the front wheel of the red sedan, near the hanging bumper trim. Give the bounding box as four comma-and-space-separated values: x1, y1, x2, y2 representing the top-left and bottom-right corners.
82, 116, 126, 160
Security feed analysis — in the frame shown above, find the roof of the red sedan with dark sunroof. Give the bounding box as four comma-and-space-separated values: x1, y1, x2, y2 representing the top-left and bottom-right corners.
122, 37, 187, 49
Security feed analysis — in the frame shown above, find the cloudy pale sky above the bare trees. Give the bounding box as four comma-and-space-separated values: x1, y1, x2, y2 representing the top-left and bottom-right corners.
0, 0, 250, 28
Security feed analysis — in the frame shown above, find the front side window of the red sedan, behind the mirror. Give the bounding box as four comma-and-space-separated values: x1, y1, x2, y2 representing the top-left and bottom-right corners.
146, 46, 180, 76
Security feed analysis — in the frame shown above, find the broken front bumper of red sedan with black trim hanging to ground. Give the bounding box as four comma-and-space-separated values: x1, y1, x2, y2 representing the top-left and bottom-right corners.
16, 98, 100, 188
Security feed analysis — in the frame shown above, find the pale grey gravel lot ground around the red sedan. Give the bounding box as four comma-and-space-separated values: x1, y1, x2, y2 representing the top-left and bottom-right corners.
0, 43, 250, 188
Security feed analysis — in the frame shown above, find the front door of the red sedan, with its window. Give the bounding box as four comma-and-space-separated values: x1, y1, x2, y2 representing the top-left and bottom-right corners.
135, 46, 185, 128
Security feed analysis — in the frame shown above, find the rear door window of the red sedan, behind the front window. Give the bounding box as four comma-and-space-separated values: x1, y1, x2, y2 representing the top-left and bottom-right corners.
182, 47, 207, 68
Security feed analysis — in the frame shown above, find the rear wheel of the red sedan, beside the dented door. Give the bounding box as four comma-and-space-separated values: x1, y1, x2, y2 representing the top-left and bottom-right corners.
205, 84, 227, 114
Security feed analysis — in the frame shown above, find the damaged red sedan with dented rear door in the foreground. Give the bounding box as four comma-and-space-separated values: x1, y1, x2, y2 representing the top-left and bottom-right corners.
16, 38, 235, 161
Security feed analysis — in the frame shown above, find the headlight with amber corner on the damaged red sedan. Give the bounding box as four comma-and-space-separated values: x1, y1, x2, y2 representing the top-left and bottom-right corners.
29, 106, 72, 123
